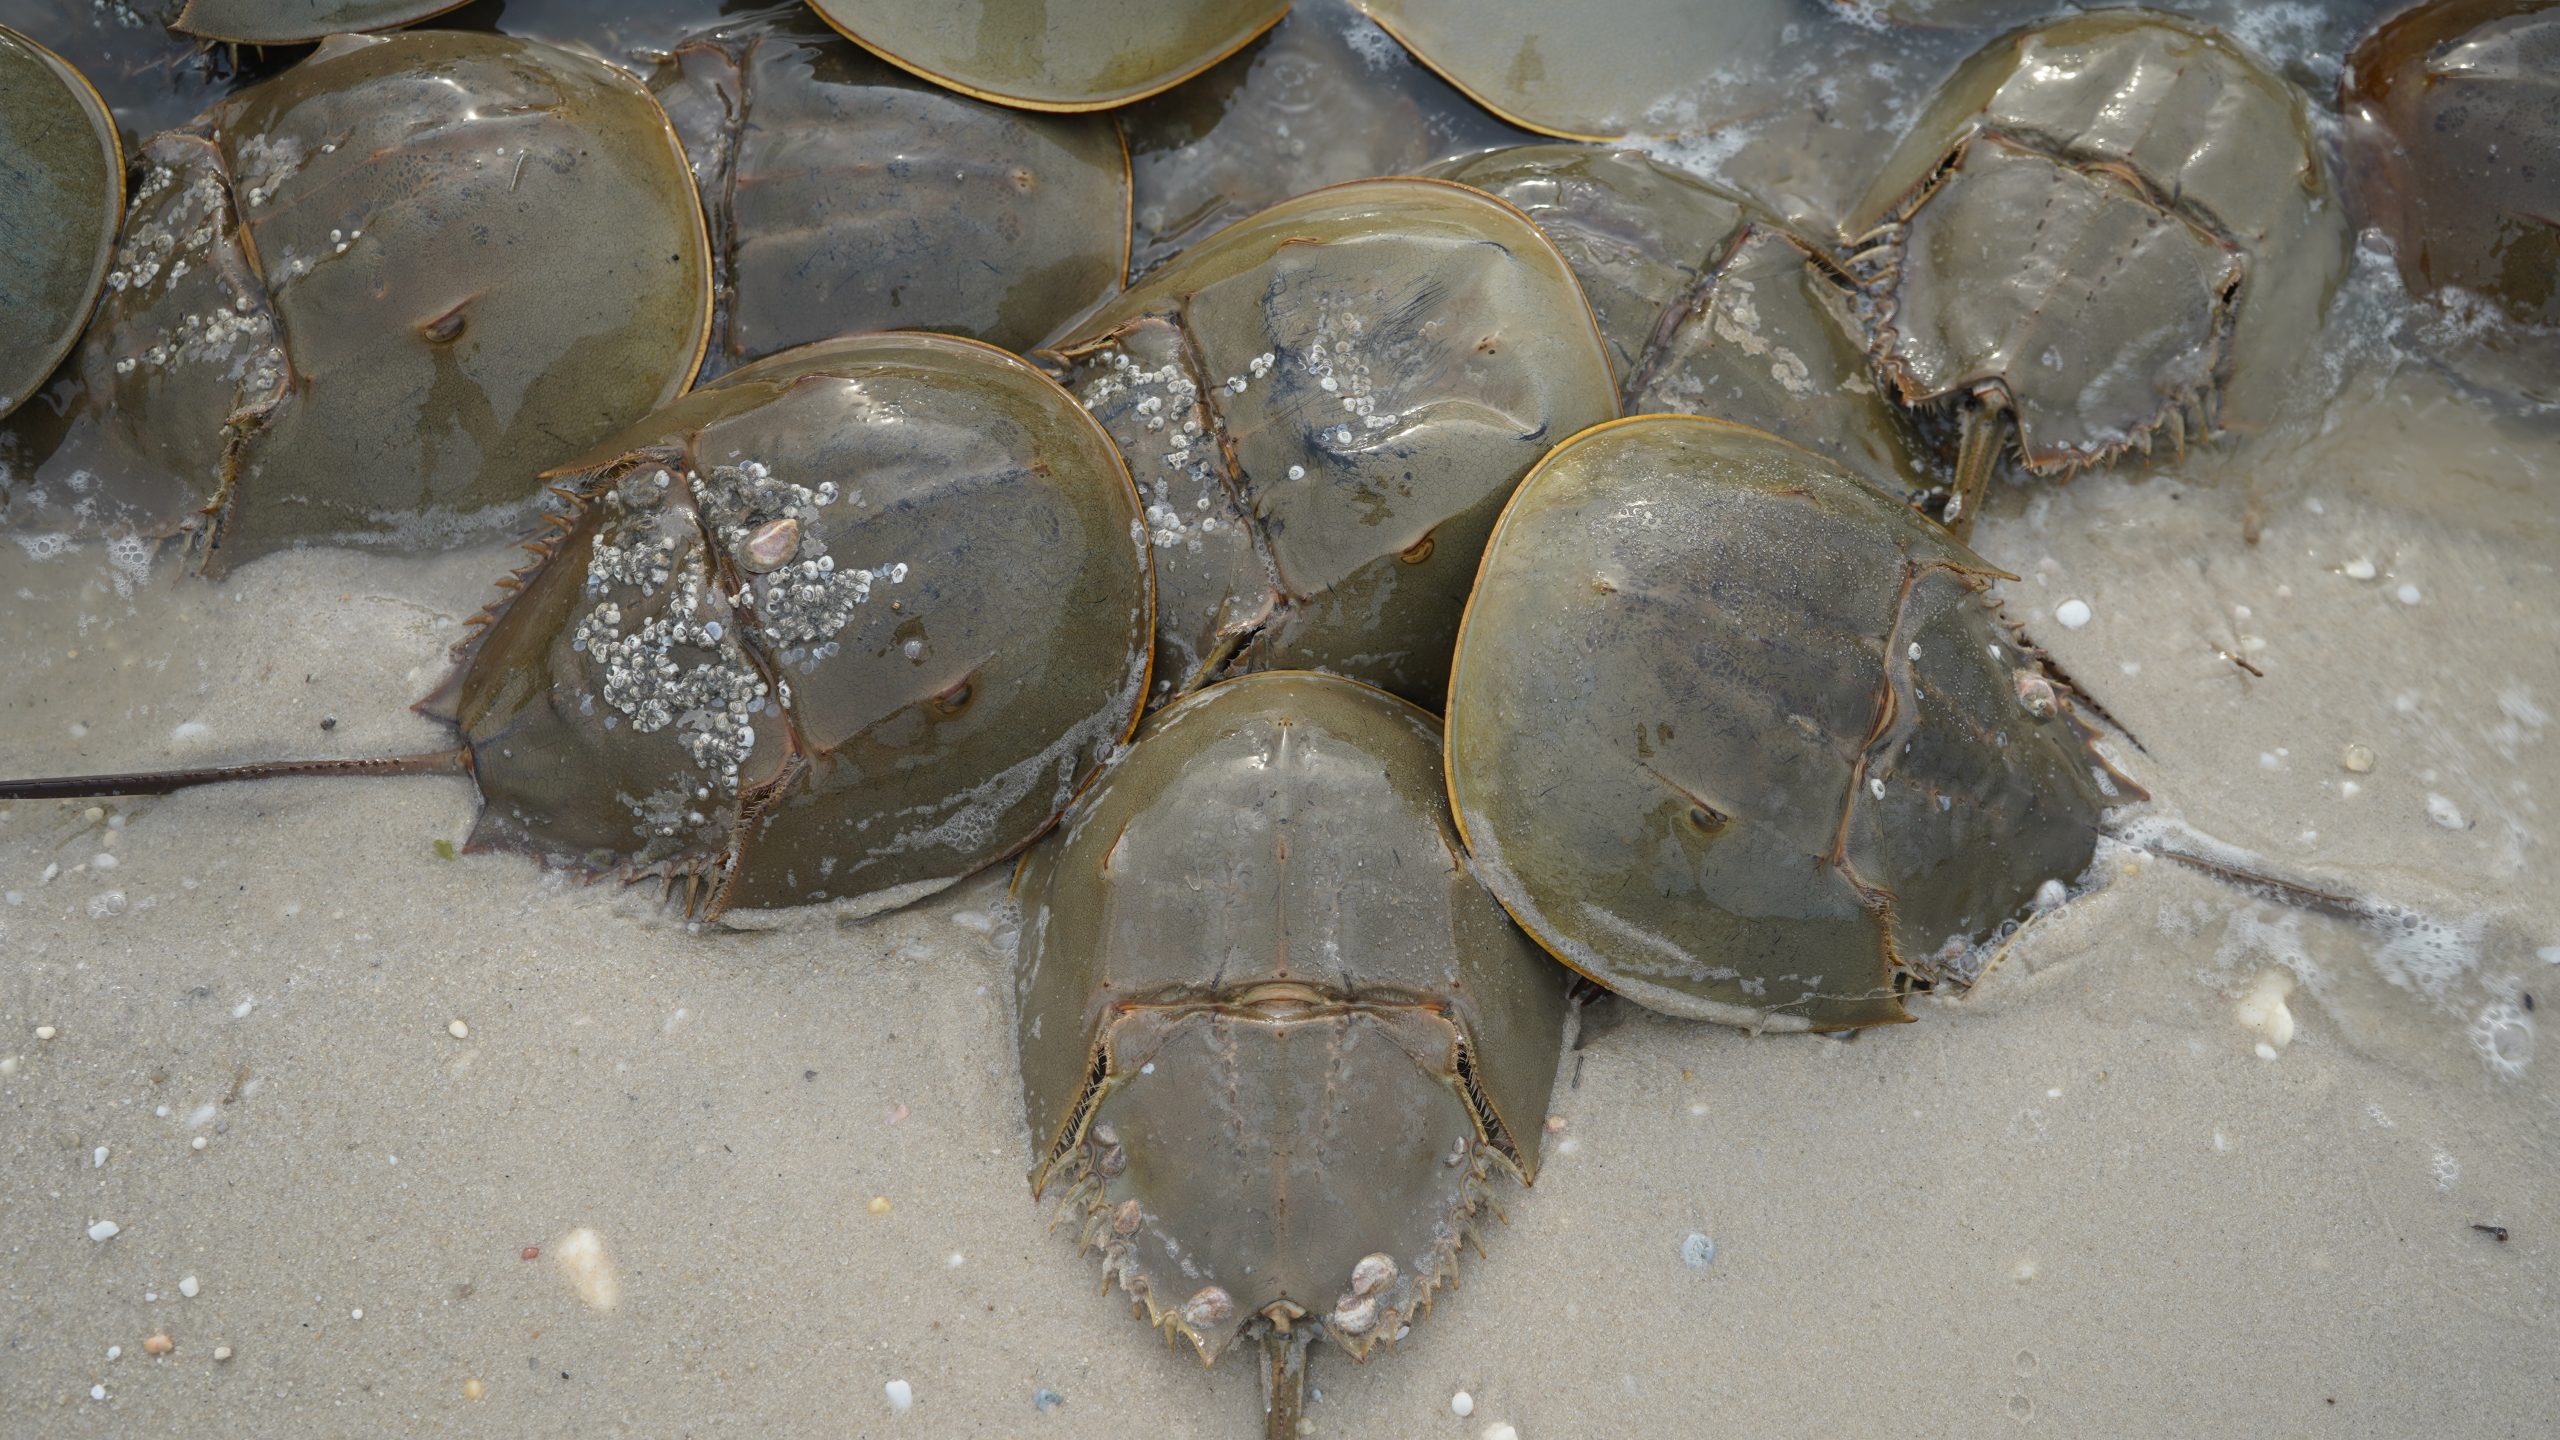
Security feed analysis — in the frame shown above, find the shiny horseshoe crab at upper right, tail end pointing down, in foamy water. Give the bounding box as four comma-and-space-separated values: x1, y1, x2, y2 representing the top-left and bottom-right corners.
1848, 10, 2348, 469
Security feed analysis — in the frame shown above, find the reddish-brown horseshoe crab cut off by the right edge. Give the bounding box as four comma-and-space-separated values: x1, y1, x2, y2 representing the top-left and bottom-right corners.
2340, 0, 2560, 405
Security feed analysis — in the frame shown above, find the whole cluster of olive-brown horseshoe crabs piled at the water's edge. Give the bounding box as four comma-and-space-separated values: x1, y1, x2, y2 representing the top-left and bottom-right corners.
0, 0, 2519, 1437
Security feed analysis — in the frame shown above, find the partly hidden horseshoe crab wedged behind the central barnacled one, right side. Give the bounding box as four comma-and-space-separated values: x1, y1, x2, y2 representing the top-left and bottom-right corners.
1431, 143, 1935, 492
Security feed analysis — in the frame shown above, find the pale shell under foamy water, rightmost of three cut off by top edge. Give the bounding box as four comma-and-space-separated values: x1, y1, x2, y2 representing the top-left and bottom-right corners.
1354, 0, 1800, 141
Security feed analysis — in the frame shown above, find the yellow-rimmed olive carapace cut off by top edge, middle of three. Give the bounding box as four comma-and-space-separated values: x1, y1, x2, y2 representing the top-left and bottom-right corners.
809, 0, 1288, 110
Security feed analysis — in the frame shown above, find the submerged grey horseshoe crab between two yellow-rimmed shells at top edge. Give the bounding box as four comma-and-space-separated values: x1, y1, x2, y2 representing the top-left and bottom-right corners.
1121, 0, 1526, 274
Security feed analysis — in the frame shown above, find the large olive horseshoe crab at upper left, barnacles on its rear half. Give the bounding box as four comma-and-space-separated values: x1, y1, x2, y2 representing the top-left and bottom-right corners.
82, 31, 712, 571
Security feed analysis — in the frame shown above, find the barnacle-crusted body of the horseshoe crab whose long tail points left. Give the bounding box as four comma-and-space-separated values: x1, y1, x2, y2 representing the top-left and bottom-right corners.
428, 333, 1152, 915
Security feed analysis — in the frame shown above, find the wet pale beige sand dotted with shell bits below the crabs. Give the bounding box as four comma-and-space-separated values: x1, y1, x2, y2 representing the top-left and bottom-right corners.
0, 5, 2560, 1440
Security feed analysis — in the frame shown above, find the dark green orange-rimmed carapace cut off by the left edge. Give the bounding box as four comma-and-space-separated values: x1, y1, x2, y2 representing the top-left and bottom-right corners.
0, 26, 125, 415
